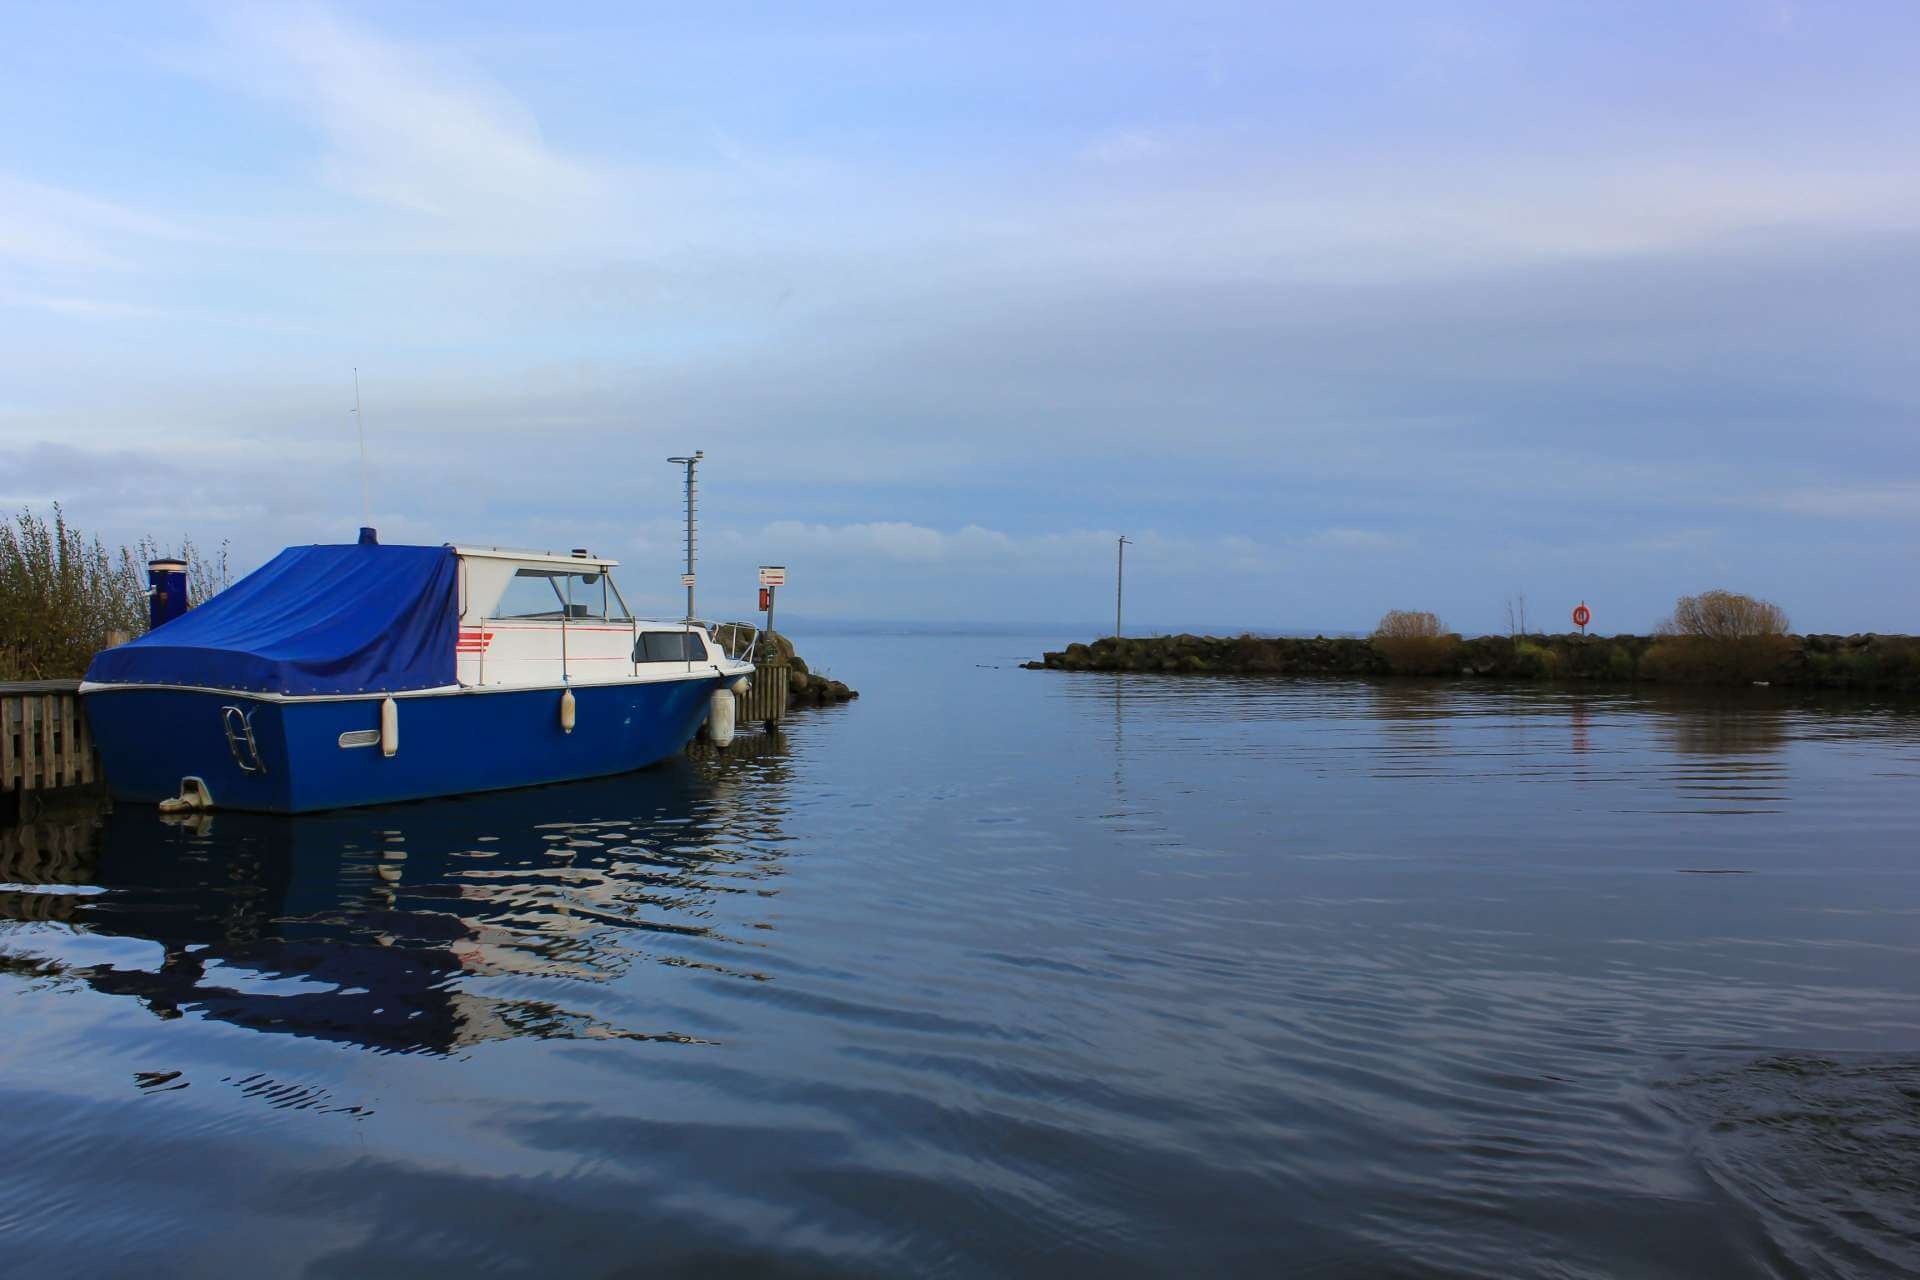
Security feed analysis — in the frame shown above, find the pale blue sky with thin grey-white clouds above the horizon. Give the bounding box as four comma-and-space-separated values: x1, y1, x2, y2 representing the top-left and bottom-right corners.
0, 0, 1920, 633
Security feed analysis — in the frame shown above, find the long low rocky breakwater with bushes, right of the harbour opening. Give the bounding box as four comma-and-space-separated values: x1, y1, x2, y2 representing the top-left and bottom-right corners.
1025, 633, 1920, 693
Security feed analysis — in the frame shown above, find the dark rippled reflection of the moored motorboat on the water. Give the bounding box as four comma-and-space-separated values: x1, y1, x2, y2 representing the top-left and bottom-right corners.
0, 752, 783, 1054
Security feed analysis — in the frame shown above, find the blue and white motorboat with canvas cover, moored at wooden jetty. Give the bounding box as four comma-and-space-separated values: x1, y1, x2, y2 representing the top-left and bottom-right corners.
81, 532, 753, 814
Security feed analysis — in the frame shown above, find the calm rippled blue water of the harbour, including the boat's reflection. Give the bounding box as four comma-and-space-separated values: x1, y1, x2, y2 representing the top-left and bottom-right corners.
0, 635, 1920, 1276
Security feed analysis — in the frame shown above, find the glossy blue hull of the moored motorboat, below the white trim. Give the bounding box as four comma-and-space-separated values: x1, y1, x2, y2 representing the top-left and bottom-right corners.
83, 676, 724, 814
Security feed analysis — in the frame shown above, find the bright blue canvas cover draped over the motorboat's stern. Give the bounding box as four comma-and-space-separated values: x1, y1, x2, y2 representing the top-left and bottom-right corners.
86, 543, 459, 695
